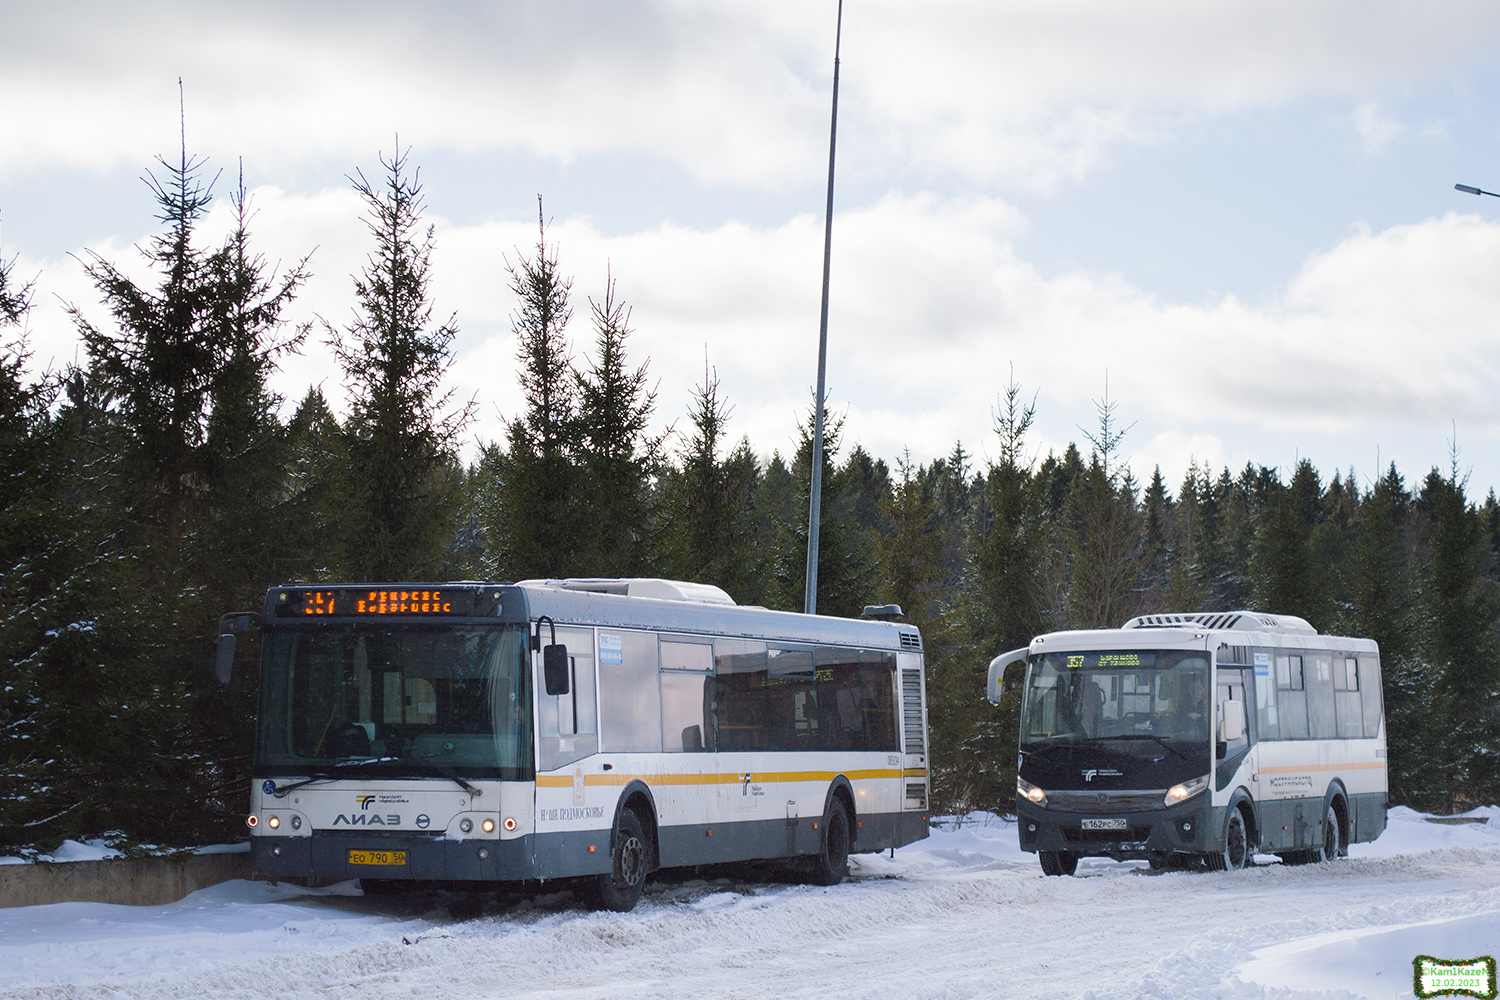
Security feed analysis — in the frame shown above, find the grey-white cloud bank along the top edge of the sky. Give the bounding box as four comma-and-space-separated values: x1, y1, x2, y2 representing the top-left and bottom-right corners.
0, 0, 1500, 189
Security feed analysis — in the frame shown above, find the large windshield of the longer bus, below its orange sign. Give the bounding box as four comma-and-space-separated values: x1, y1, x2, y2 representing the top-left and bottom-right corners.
257, 624, 531, 780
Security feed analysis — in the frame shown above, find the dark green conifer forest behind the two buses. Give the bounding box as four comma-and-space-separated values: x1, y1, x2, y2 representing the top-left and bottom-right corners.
0, 150, 1500, 853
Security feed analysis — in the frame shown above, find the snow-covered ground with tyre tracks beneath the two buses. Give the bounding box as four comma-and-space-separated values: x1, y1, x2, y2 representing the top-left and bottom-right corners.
0, 808, 1500, 1000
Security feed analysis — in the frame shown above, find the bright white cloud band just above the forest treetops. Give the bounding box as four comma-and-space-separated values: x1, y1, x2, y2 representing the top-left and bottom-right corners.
18, 189, 1500, 483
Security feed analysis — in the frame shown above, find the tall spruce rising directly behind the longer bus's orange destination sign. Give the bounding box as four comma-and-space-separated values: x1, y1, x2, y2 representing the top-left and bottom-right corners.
329, 142, 474, 580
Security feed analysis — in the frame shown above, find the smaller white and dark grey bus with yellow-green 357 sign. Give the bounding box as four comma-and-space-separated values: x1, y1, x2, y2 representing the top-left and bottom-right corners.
989, 612, 1386, 876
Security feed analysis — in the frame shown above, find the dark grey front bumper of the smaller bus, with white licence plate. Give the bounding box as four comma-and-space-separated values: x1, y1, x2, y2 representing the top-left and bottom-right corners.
1016, 795, 1217, 861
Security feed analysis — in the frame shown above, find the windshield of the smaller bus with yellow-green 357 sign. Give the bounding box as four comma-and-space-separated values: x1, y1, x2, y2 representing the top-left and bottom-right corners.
1022, 649, 1212, 745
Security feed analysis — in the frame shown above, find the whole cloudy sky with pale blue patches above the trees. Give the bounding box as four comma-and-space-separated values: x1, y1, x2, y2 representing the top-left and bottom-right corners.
0, 0, 1500, 496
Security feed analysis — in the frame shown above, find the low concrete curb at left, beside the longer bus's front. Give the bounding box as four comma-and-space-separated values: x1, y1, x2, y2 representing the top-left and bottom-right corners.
0, 852, 251, 907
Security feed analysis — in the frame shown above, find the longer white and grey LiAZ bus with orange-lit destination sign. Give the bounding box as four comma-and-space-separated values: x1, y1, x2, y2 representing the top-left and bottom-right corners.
215, 579, 929, 910
